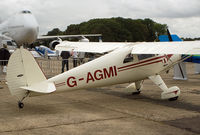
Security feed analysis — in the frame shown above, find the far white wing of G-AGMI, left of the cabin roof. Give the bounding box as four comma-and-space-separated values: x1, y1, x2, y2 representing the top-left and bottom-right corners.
55, 41, 130, 53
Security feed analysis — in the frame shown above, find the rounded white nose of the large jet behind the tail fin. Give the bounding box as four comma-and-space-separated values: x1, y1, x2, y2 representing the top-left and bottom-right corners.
0, 10, 39, 45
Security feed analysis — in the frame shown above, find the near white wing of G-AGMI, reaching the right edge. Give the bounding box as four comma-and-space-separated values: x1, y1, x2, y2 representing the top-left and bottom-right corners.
131, 41, 200, 55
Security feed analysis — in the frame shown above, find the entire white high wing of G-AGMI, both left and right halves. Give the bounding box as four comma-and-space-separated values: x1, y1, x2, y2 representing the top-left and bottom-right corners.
55, 41, 200, 55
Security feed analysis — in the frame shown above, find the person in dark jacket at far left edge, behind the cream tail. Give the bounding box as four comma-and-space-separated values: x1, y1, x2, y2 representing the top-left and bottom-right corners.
0, 44, 10, 71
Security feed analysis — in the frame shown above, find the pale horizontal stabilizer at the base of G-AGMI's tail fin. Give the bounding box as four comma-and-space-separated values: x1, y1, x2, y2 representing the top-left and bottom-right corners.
20, 81, 56, 93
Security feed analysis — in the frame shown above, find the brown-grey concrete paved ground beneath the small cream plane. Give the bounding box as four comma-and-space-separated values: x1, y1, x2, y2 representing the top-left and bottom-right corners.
0, 64, 200, 135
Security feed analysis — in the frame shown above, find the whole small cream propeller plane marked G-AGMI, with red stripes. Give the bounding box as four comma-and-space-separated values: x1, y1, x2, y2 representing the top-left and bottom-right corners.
6, 41, 200, 108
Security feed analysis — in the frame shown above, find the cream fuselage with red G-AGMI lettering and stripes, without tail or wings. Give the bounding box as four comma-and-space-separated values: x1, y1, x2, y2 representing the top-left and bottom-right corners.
48, 47, 181, 92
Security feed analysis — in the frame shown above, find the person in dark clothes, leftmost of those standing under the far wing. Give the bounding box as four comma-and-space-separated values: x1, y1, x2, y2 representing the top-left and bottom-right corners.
60, 51, 70, 73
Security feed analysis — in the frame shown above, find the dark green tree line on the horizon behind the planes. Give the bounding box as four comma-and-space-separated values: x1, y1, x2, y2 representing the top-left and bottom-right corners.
47, 17, 167, 42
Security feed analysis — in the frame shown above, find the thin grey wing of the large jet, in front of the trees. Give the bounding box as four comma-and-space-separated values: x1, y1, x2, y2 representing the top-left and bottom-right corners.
37, 34, 102, 40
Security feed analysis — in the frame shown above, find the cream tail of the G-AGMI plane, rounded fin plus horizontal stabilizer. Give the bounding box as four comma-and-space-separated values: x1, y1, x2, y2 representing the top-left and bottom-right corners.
6, 47, 56, 100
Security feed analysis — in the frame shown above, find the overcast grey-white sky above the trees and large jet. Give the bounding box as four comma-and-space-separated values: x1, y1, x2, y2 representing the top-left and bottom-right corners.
0, 0, 200, 38
